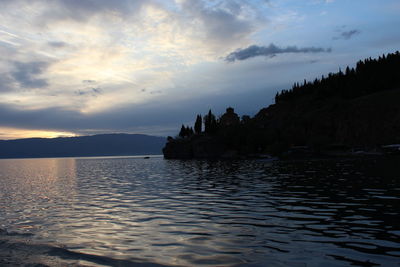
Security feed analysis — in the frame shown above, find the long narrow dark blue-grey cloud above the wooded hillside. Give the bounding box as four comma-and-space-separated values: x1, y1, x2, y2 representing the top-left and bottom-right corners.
225, 44, 332, 62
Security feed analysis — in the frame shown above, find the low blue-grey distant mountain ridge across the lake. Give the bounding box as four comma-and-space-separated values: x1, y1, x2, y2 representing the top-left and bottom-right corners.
0, 134, 166, 158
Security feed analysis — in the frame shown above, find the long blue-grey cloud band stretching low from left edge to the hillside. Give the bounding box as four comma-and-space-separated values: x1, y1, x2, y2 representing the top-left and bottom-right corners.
0, 73, 282, 135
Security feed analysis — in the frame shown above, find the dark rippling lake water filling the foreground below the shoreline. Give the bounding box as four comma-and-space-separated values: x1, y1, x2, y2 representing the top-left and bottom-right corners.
0, 158, 400, 267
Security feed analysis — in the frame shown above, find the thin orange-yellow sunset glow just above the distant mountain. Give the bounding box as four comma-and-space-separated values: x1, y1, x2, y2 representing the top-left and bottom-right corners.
0, 127, 78, 140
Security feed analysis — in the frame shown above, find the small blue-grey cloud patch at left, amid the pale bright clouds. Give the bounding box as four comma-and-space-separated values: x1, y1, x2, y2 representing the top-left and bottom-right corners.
11, 61, 49, 88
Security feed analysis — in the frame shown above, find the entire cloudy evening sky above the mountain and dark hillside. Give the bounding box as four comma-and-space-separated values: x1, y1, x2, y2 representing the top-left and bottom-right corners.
0, 0, 400, 139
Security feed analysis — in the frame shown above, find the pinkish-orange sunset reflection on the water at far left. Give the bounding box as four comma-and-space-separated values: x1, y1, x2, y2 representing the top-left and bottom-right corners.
0, 159, 76, 234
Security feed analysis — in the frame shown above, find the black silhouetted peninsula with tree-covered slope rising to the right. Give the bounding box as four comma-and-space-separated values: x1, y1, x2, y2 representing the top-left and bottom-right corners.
163, 51, 400, 159
